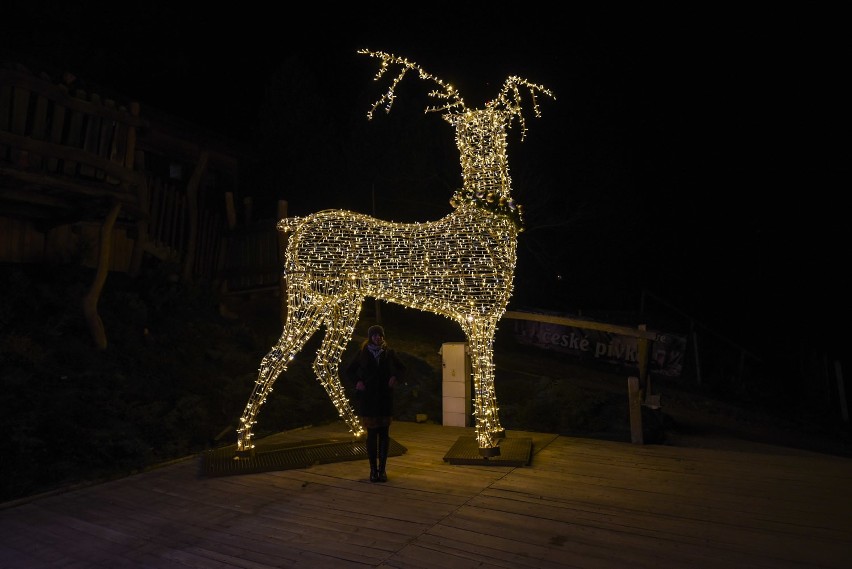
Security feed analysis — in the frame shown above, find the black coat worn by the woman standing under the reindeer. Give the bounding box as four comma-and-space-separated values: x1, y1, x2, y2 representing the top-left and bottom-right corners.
346, 344, 405, 417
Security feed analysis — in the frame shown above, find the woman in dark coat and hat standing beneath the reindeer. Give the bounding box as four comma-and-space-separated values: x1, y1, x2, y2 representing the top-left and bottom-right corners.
346, 325, 405, 482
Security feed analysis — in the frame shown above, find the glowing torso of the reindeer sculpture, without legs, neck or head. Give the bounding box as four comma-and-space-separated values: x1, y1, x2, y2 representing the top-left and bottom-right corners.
278, 205, 517, 316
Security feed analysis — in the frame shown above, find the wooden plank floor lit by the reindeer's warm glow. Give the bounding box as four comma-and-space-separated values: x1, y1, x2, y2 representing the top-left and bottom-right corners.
0, 422, 852, 569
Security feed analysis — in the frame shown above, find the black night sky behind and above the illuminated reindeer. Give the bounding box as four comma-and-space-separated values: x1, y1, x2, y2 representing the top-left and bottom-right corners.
0, 1, 848, 361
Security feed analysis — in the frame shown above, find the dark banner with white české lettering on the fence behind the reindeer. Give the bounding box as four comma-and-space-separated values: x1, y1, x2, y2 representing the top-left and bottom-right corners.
513, 320, 686, 377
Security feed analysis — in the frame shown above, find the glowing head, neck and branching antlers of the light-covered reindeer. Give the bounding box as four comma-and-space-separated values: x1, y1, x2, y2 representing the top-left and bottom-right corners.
358, 49, 556, 230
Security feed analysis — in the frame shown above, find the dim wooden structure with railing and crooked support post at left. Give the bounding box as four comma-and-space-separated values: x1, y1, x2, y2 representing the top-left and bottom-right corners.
0, 63, 260, 347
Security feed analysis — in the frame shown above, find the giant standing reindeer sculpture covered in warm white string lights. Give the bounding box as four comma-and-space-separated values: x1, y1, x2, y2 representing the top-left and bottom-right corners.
237, 50, 553, 458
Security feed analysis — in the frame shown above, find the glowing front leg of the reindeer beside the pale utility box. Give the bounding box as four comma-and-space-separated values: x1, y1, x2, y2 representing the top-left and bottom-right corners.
462, 320, 506, 457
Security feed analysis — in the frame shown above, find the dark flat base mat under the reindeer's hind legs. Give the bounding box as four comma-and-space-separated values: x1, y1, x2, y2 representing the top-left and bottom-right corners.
201, 438, 408, 476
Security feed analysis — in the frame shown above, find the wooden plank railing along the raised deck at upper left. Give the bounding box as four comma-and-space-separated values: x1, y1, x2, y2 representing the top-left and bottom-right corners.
0, 62, 146, 216
